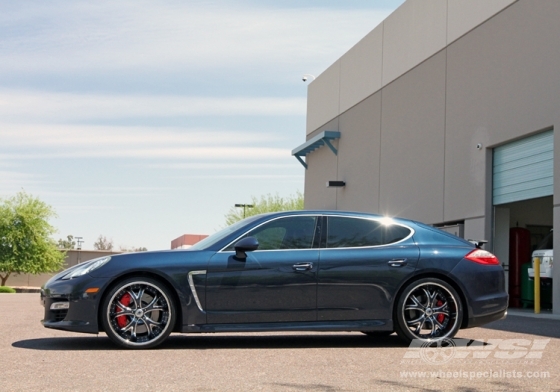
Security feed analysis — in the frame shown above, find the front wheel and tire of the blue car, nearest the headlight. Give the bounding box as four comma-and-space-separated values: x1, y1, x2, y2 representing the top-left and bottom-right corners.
101, 277, 176, 349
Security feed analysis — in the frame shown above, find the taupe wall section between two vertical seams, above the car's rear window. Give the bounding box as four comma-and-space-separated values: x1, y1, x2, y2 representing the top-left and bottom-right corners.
378, 52, 445, 222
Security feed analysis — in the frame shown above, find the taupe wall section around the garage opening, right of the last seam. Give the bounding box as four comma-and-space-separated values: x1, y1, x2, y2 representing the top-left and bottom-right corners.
445, 0, 560, 220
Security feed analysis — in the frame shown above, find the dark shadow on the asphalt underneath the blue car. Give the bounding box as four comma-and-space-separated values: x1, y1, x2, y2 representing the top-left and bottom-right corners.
12, 333, 409, 351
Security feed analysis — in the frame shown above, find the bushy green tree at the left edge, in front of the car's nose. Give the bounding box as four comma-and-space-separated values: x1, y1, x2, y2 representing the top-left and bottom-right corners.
0, 192, 65, 286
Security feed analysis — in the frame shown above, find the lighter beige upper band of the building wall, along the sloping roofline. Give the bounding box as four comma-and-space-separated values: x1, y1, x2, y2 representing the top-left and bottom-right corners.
307, 0, 516, 135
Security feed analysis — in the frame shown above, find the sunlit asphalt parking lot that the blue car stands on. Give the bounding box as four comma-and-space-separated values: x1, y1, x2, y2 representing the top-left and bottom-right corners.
0, 294, 560, 391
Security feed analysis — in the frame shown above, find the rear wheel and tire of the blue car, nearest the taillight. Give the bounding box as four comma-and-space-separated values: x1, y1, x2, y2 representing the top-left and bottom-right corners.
394, 278, 463, 343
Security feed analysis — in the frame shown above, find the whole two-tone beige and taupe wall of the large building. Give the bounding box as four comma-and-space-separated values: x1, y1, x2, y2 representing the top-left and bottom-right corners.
305, 0, 560, 313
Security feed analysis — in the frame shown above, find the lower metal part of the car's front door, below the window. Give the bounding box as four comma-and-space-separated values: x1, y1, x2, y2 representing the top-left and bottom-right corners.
206, 249, 319, 324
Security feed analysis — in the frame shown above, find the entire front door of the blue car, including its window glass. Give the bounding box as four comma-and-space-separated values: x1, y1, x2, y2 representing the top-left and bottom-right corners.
206, 215, 320, 324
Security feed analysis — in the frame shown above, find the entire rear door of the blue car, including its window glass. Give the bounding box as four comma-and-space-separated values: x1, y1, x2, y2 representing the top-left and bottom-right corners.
317, 216, 419, 321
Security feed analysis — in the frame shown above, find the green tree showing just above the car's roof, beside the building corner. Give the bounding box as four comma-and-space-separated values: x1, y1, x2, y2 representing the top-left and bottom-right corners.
225, 191, 303, 226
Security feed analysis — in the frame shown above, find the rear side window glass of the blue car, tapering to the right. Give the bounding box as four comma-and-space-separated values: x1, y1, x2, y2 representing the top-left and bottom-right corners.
327, 216, 410, 248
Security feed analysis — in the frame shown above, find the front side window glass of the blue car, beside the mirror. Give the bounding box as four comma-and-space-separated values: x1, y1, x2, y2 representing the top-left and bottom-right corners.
225, 216, 317, 250
